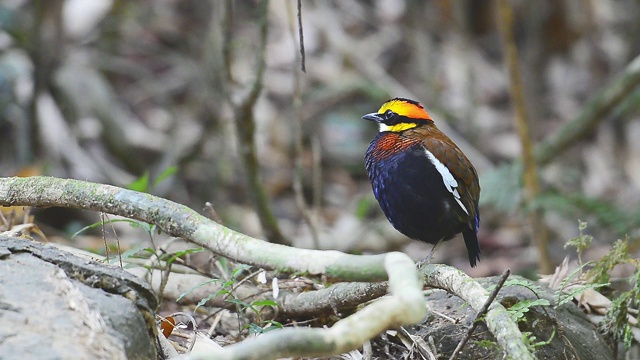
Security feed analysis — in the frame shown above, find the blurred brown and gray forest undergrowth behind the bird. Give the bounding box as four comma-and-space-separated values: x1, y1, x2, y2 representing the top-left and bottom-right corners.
0, 0, 640, 275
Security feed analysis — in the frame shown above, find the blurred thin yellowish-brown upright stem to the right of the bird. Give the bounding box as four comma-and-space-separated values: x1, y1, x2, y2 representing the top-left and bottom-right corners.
498, 0, 553, 274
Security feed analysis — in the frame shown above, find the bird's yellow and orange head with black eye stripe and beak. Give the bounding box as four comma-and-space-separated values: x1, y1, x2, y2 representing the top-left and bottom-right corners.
362, 98, 433, 132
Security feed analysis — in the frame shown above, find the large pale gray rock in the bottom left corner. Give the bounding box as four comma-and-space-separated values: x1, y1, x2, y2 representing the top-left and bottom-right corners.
0, 236, 157, 359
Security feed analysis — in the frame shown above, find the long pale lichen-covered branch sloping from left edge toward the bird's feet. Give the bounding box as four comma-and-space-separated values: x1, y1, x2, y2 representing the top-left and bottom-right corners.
0, 176, 387, 281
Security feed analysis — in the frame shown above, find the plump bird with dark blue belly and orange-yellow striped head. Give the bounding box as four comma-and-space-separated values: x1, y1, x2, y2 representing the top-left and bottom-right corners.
362, 97, 480, 267
